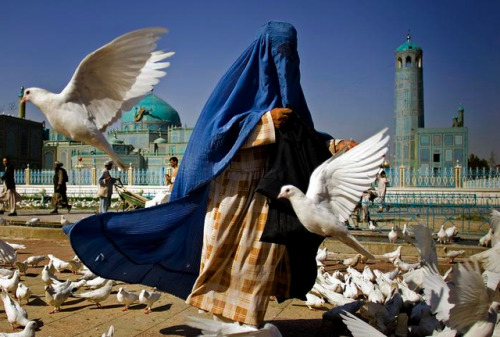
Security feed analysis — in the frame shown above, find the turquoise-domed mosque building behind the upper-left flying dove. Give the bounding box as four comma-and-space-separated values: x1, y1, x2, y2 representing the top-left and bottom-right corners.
42, 91, 193, 169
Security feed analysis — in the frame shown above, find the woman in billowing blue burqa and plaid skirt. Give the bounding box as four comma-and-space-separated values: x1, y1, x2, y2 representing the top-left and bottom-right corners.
65, 22, 350, 325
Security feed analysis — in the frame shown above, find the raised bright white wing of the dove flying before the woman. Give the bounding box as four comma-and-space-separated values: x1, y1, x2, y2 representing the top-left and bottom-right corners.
306, 128, 389, 221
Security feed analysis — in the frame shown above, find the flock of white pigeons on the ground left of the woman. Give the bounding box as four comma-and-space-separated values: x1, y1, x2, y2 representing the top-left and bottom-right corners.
0, 240, 162, 337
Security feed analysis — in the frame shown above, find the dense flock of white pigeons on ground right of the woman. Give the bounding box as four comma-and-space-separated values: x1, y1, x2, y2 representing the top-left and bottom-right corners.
292, 210, 500, 337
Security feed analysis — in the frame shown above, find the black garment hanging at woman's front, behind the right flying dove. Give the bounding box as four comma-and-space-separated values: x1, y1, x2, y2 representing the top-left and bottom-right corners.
257, 114, 331, 300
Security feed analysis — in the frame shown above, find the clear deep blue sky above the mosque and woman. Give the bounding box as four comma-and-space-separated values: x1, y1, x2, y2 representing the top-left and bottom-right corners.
0, 0, 500, 163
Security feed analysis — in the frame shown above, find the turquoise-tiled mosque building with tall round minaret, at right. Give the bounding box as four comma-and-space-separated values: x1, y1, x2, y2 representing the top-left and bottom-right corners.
391, 34, 469, 173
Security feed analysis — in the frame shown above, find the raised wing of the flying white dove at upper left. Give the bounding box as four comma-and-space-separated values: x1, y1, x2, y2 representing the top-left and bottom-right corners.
61, 28, 173, 131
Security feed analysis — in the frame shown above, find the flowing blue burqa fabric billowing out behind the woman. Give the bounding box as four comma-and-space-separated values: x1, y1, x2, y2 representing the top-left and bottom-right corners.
64, 22, 313, 298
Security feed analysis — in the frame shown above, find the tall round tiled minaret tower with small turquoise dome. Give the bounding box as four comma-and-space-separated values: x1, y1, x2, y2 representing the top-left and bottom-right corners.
393, 33, 424, 167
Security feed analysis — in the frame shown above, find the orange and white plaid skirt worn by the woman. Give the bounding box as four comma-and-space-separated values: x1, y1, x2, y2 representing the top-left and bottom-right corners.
186, 146, 289, 325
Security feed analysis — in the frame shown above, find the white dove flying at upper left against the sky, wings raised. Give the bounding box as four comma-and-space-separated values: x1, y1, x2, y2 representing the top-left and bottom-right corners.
21, 28, 174, 169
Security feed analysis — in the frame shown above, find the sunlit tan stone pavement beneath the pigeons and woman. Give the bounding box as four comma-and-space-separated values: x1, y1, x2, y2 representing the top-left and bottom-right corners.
0, 209, 482, 337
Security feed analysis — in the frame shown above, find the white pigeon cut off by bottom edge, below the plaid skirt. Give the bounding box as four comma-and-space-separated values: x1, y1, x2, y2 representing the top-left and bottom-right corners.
186, 316, 282, 337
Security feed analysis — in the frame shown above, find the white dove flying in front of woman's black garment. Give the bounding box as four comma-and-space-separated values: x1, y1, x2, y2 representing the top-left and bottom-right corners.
278, 128, 389, 259
